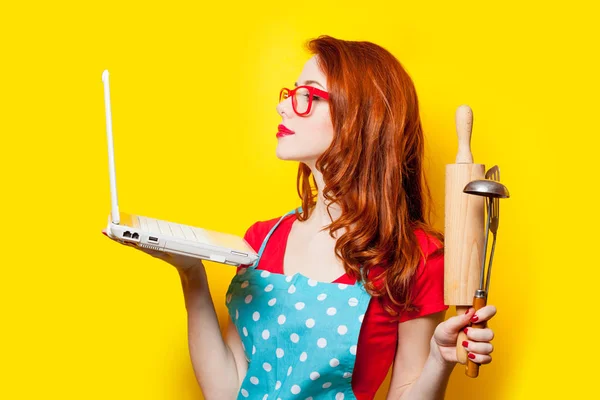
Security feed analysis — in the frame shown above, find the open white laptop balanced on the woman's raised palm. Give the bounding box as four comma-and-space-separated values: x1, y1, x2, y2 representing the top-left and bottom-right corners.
102, 70, 258, 266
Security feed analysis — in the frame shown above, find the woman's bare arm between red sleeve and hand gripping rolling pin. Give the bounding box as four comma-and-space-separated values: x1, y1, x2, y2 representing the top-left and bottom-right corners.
387, 311, 454, 400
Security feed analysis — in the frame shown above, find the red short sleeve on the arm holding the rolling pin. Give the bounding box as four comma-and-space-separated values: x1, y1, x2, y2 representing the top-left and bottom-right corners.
400, 233, 449, 322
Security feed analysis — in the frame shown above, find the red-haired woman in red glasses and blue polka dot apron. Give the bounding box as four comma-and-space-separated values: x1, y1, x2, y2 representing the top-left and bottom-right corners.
112, 36, 496, 400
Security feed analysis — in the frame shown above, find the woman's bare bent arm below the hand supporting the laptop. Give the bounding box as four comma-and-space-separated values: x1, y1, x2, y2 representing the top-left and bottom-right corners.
178, 266, 248, 400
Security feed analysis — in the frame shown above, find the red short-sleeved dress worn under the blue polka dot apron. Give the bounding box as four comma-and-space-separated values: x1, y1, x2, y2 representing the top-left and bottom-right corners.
237, 214, 449, 400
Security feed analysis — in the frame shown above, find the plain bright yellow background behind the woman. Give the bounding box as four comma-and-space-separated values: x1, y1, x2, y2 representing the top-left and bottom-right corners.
0, 1, 600, 400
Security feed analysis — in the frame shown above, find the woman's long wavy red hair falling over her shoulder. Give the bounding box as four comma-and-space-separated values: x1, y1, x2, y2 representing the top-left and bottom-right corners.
296, 36, 444, 316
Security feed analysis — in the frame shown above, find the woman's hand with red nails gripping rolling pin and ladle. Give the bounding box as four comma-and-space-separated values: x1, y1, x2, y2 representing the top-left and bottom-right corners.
431, 305, 496, 364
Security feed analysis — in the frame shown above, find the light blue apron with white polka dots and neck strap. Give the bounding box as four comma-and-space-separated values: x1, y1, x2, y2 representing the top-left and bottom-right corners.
226, 210, 371, 400
